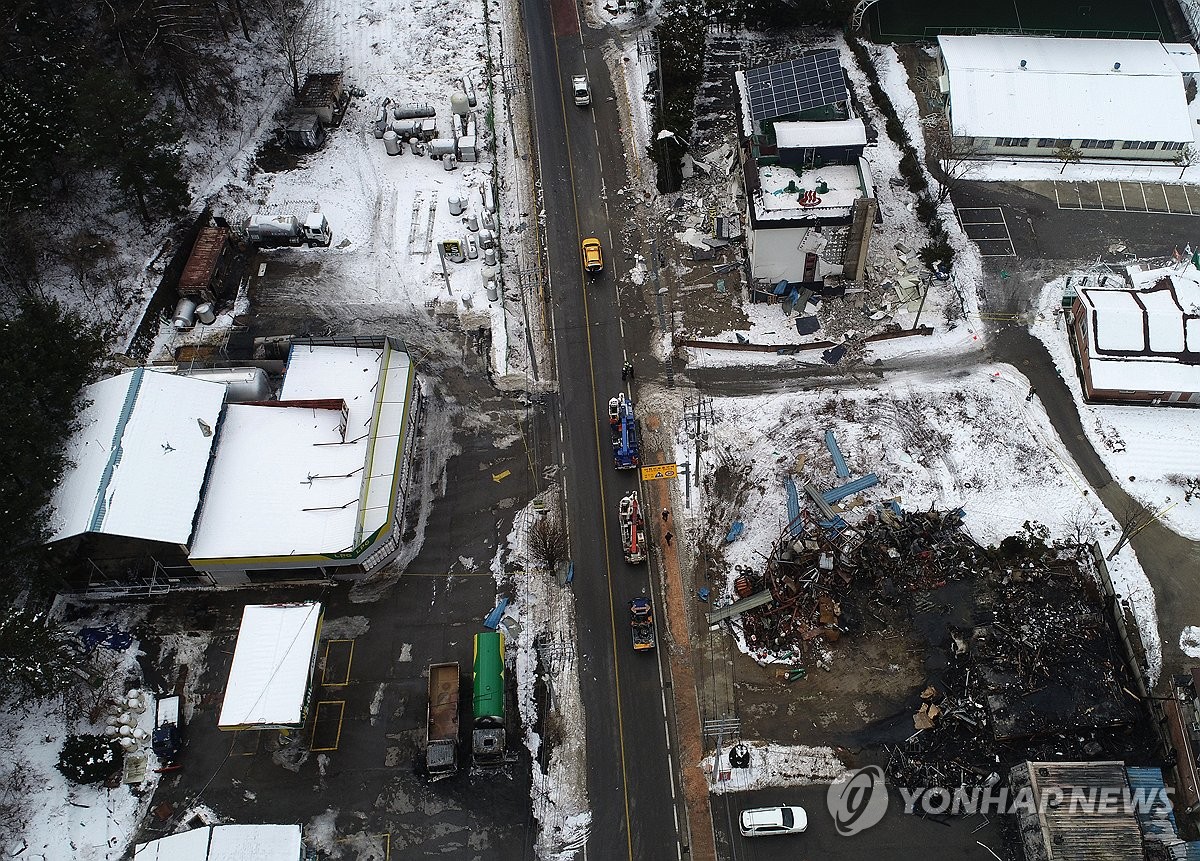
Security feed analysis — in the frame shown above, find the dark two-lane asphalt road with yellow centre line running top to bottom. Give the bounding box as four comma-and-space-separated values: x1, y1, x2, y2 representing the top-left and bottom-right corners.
523, 0, 680, 861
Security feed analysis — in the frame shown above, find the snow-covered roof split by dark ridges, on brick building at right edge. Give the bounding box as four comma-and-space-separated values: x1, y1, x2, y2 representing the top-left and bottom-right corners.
1079, 264, 1200, 392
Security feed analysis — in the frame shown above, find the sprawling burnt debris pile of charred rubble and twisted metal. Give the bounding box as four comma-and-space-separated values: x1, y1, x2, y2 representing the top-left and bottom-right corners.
734, 504, 1145, 787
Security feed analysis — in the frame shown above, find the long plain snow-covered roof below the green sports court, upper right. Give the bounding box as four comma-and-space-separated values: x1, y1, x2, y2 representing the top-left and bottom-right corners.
937, 36, 1192, 142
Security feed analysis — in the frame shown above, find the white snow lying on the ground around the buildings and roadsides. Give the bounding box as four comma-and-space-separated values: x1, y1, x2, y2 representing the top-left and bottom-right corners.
9, 10, 1200, 859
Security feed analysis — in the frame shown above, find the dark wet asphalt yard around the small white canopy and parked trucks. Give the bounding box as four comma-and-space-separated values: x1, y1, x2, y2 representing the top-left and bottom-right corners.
139, 571, 534, 861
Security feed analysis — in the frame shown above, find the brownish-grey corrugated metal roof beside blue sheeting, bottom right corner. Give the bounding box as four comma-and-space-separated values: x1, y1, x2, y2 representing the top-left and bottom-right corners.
1028, 761, 1145, 861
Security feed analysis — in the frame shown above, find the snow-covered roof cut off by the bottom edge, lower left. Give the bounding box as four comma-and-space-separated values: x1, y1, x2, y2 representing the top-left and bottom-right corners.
133, 825, 304, 861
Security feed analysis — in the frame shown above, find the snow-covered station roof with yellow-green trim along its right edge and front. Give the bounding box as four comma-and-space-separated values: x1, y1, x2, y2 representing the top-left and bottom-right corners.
191, 345, 412, 566
